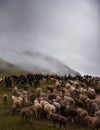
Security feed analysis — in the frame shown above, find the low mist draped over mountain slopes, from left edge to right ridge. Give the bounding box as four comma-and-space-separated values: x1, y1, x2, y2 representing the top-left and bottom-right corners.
0, 51, 80, 76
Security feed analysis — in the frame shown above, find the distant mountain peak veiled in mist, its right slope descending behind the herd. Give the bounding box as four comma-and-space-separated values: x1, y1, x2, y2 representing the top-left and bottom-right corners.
20, 51, 80, 76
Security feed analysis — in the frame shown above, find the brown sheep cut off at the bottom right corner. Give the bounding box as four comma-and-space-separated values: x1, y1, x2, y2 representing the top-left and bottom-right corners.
85, 115, 100, 130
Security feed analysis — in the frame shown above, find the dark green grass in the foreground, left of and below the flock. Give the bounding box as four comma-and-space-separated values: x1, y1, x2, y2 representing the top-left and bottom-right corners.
0, 87, 88, 130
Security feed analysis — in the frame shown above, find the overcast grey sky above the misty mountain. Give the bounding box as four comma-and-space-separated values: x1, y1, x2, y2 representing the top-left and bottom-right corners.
0, 0, 100, 76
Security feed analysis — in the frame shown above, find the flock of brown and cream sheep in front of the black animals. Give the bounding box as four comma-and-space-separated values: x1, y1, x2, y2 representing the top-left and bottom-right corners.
2, 73, 100, 130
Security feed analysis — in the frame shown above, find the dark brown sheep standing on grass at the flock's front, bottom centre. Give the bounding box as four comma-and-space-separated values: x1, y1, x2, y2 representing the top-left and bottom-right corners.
49, 113, 67, 129
